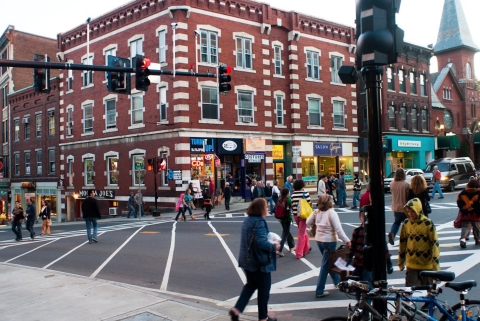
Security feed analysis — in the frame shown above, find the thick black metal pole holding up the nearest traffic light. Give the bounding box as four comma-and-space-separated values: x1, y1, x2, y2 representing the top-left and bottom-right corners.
362, 65, 387, 312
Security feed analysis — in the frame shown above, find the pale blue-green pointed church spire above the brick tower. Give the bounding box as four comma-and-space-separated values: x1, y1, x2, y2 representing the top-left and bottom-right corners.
434, 0, 480, 54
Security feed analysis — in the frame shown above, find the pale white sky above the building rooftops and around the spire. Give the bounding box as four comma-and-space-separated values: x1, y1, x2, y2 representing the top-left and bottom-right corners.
0, 0, 480, 79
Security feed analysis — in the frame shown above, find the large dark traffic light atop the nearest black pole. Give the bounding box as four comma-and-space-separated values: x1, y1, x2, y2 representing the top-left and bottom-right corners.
356, 0, 404, 70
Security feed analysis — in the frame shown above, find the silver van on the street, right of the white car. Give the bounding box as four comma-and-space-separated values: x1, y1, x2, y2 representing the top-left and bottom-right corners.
423, 157, 476, 191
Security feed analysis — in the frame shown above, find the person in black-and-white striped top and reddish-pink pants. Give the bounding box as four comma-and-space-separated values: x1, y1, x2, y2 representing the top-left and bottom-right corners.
291, 179, 312, 259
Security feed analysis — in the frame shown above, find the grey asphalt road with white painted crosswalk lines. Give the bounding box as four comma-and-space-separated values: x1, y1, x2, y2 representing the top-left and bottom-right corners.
0, 191, 480, 320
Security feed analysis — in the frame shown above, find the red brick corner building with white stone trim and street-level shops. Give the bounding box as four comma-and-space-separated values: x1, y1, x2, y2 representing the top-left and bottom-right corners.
58, 0, 358, 219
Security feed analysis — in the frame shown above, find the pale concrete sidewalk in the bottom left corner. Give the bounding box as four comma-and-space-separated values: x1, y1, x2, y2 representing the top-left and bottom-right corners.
0, 263, 257, 321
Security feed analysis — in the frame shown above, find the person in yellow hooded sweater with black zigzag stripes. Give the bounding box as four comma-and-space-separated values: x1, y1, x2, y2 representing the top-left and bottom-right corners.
398, 198, 440, 290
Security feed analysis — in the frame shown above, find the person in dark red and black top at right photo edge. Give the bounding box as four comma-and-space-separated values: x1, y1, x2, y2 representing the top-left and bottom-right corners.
457, 179, 480, 249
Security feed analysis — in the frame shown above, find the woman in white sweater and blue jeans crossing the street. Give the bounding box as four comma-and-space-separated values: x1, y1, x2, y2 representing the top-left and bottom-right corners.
306, 195, 351, 298
